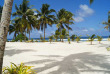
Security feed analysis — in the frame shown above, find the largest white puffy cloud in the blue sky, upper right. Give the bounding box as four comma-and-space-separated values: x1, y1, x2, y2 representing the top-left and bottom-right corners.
74, 4, 94, 22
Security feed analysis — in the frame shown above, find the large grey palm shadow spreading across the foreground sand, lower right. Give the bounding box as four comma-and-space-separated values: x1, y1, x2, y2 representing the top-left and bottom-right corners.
26, 52, 110, 74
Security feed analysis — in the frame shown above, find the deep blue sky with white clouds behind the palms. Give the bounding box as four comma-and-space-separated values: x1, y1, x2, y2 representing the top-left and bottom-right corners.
0, 0, 110, 39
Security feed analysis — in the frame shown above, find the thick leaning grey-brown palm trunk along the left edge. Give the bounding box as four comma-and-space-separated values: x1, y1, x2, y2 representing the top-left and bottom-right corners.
0, 0, 13, 74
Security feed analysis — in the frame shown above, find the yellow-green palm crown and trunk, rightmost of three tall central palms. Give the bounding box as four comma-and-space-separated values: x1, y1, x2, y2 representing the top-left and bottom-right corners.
56, 8, 72, 41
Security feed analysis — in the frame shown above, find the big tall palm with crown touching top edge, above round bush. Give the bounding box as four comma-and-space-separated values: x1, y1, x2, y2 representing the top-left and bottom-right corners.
12, 0, 37, 39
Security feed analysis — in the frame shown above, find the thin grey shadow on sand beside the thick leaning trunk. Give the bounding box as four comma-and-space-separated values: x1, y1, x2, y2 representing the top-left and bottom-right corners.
4, 49, 35, 56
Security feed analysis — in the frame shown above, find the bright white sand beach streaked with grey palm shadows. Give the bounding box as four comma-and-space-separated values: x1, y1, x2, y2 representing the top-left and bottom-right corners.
3, 41, 110, 74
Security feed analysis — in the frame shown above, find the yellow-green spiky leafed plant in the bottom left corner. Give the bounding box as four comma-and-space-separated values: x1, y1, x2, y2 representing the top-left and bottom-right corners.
3, 63, 36, 74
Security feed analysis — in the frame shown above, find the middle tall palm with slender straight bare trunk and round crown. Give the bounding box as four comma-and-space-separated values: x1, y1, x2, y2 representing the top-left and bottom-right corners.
36, 4, 55, 41
